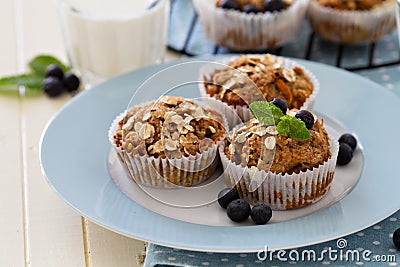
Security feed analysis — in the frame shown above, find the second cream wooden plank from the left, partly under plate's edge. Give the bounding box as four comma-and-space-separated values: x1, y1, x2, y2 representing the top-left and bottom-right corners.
18, 0, 86, 267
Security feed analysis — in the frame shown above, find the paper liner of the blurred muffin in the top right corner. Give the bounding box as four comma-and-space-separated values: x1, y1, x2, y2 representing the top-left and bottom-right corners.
308, 0, 396, 44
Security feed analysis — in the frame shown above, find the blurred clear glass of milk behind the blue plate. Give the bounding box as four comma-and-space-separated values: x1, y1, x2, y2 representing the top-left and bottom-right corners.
58, 0, 169, 86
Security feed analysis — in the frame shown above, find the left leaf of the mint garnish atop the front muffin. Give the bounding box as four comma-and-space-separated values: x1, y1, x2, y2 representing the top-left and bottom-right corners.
250, 101, 283, 125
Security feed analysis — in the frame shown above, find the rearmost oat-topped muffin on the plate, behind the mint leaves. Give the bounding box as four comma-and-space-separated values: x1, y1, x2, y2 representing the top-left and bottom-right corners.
199, 54, 319, 127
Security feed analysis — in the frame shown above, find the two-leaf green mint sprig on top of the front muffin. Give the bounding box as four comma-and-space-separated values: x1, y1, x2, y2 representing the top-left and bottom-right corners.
249, 101, 311, 141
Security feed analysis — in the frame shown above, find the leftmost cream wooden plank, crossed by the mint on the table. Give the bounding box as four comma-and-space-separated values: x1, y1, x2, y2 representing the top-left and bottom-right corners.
0, 1, 24, 266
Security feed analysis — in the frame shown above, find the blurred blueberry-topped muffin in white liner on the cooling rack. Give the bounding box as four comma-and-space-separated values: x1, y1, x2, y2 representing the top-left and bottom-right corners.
193, 0, 308, 51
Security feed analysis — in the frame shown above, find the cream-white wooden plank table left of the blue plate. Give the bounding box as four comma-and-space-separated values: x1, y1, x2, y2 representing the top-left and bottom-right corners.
0, 0, 178, 267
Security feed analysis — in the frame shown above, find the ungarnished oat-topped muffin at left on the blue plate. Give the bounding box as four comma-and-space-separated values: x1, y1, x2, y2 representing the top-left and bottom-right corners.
109, 96, 225, 188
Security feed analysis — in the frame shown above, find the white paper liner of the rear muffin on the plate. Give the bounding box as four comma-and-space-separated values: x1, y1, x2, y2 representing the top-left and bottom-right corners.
198, 54, 320, 130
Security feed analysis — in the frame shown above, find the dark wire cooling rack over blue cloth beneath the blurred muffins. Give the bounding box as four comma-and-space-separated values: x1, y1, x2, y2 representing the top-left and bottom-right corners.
168, 0, 400, 71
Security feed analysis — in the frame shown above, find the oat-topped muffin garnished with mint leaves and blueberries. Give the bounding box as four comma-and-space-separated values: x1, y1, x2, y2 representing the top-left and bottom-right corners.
220, 101, 338, 210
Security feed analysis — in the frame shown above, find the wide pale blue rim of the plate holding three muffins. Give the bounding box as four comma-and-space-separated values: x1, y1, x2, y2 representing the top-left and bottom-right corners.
40, 59, 400, 252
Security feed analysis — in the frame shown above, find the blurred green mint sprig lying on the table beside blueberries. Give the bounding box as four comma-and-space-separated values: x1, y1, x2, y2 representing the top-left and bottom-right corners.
0, 55, 70, 93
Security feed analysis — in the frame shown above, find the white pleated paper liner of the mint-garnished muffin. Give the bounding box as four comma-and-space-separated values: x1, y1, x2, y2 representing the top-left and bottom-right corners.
219, 140, 339, 210
